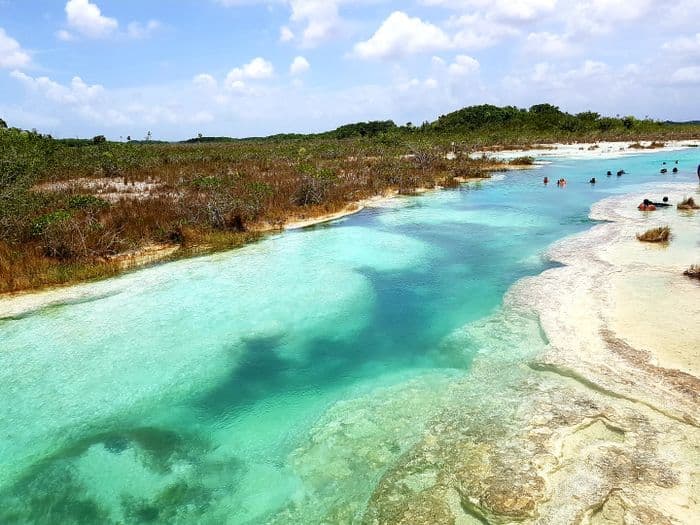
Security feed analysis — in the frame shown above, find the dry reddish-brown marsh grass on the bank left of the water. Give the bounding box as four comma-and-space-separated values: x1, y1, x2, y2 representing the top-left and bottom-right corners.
0, 141, 506, 292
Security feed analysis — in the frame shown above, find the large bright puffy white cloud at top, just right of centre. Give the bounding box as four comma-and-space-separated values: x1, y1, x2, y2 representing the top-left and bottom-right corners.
354, 11, 452, 59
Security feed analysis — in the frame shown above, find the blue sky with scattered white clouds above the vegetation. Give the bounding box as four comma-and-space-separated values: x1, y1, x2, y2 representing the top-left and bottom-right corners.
0, 0, 700, 140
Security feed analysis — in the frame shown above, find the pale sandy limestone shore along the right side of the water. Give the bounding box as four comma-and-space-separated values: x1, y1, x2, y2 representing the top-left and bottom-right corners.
364, 184, 700, 525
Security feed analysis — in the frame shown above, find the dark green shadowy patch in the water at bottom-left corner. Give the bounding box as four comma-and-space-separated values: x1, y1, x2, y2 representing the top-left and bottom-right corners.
0, 427, 245, 525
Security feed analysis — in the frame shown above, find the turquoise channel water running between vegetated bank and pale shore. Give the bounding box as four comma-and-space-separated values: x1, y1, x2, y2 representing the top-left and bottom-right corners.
0, 150, 700, 524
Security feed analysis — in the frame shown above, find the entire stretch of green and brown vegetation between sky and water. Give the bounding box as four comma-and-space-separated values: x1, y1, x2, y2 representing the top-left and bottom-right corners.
0, 104, 700, 292
